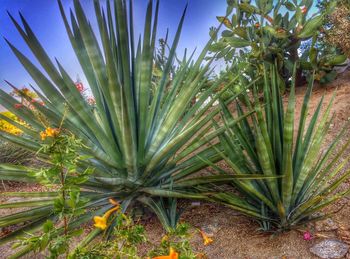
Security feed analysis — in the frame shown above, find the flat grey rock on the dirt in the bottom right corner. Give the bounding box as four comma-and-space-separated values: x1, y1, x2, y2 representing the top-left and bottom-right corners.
310, 239, 349, 259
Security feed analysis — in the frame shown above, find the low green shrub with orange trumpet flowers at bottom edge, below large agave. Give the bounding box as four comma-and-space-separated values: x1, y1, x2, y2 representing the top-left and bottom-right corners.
71, 221, 208, 259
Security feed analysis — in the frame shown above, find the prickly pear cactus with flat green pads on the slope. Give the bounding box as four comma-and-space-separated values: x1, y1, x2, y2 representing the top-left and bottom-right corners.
210, 0, 341, 89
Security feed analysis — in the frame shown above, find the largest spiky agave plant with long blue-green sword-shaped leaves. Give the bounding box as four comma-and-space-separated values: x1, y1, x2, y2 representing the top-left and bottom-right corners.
0, 0, 262, 255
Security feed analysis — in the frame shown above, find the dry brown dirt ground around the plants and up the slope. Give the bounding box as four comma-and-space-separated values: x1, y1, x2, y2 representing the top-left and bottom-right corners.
0, 72, 350, 259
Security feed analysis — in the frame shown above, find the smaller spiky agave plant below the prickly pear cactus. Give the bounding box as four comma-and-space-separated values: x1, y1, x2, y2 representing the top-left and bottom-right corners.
212, 67, 350, 231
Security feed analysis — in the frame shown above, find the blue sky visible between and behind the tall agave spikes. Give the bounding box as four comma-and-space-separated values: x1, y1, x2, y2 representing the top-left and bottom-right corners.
0, 0, 226, 94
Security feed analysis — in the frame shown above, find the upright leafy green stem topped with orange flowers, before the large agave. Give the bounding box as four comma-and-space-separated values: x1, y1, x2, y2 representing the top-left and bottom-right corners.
11, 121, 93, 258
